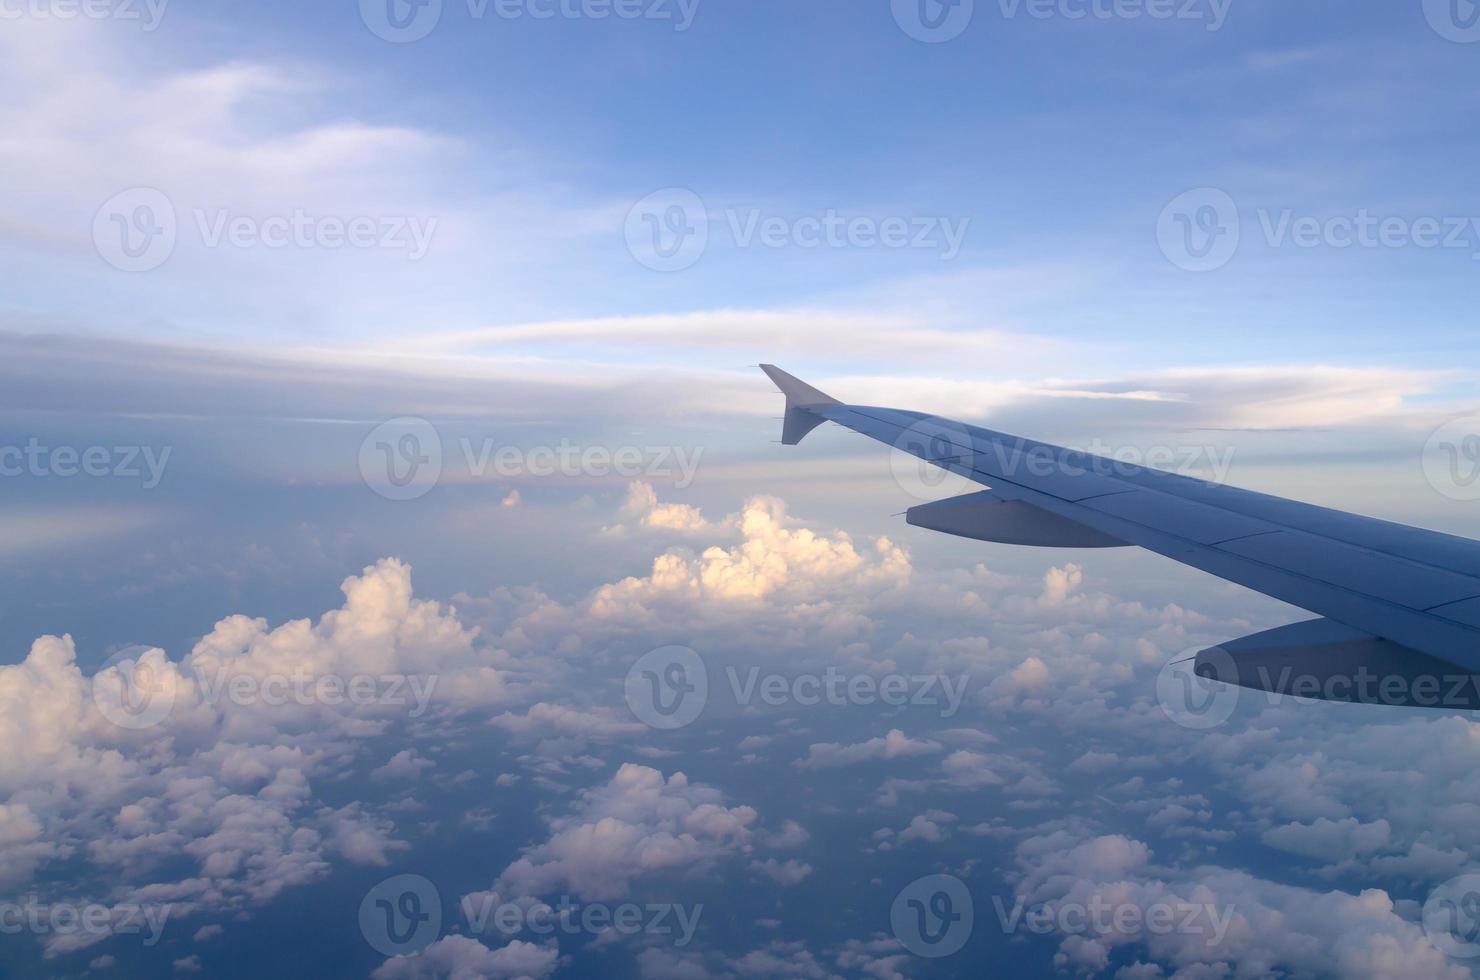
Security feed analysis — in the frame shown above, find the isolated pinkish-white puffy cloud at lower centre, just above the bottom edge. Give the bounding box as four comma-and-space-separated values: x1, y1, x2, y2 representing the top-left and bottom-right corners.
494, 762, 756, 902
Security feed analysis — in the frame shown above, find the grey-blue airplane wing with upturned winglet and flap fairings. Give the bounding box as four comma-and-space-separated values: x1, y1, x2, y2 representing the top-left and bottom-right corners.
761, 364, 1480, 709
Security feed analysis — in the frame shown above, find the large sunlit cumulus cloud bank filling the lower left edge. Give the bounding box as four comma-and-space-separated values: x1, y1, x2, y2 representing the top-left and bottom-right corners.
0, 561, 532, 953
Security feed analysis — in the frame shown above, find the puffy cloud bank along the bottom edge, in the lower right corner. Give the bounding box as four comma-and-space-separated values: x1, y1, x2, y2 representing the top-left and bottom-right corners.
1015, 830, 1470, 980
